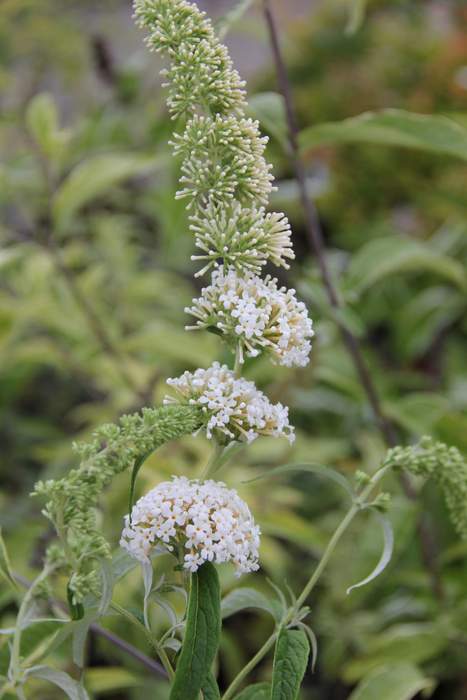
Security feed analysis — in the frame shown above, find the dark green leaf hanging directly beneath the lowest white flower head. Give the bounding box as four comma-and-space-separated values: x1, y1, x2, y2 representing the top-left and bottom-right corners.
170, 562, 221, 700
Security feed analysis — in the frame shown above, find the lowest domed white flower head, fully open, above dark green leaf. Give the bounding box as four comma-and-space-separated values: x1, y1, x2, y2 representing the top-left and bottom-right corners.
120, 476, 260, 575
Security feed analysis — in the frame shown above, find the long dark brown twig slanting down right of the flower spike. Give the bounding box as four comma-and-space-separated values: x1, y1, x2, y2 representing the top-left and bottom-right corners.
263, 0, 443, 599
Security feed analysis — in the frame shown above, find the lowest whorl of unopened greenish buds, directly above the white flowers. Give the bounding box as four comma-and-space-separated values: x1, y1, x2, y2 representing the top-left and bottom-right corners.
190, 202, 295, 277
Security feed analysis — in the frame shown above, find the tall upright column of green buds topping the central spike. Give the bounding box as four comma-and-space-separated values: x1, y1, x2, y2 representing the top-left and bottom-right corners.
134, 0, 294, 274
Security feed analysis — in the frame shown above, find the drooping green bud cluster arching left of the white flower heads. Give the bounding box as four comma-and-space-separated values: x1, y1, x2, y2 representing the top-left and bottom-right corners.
34, 406, 201, 603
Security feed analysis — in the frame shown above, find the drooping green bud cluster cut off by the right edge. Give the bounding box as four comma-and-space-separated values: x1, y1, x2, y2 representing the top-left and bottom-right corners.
384, 437, 467, 539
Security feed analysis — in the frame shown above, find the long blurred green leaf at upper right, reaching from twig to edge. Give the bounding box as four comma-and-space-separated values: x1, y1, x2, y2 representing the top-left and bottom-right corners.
299, 109, 467, 160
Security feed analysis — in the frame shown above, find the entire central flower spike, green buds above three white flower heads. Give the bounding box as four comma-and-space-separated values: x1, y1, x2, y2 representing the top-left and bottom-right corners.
121, 0, 313, 574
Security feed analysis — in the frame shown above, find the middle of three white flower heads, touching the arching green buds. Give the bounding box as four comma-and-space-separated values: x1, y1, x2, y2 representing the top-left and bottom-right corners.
165, 362, 295, 443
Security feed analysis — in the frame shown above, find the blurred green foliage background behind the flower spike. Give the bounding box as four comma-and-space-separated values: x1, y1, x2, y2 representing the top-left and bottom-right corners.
0, 0, 467, 700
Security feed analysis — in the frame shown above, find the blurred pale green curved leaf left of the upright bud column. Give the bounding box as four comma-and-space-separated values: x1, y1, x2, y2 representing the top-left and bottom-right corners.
52, 153, 160, 228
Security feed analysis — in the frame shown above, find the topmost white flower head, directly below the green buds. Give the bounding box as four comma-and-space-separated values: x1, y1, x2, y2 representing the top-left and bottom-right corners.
185, 266, 313, 367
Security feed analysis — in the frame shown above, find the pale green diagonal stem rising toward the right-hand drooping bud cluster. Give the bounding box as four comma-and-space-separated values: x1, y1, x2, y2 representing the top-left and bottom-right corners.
222, 467, 391, 700
